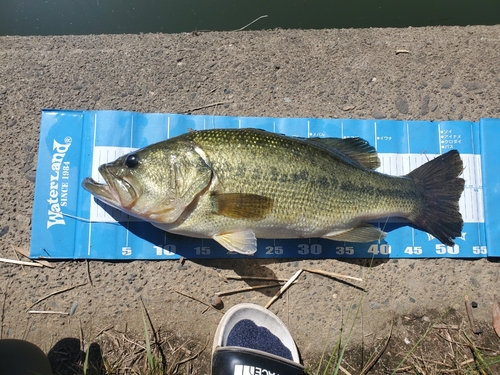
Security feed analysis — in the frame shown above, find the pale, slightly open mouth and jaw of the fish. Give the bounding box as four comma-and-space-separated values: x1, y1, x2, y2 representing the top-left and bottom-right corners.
82, 165, 138, 208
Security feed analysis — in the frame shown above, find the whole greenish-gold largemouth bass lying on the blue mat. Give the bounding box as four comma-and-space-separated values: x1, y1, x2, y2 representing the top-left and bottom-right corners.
82, 128, 465, 255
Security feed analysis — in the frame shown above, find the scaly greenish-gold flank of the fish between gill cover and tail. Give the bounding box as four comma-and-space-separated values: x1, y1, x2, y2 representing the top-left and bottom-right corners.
174, 130, 420, 238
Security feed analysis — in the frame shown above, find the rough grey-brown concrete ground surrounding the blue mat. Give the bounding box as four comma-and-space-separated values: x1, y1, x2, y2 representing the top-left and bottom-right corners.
0, 26, 500, 374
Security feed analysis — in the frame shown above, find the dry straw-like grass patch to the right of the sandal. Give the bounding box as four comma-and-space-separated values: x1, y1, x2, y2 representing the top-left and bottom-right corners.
308, 315, 500, 375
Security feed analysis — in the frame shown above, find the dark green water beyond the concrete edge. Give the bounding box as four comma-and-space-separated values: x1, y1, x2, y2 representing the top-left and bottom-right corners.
0, 0, 500, 35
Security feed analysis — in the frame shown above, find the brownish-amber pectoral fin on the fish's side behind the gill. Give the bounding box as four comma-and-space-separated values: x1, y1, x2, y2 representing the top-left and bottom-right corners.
211, 193, 273, 220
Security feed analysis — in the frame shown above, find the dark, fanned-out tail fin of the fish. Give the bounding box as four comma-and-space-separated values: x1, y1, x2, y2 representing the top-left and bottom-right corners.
407, 150, 465, 246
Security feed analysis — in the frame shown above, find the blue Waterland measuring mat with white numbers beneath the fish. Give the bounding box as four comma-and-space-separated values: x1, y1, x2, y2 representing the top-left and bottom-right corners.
30, 110, 500, 260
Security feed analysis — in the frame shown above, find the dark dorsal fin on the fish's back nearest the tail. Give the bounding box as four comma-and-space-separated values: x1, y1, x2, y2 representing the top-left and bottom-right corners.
304, 137, 380, 169
